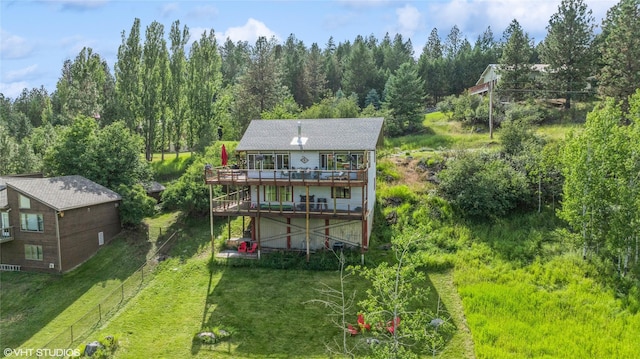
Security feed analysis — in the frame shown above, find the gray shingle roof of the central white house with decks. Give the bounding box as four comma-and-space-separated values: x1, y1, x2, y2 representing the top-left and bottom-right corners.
236, 117, 384, 151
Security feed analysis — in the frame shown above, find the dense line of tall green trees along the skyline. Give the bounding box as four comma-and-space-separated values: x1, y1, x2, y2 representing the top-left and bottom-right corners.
0, 0, 640, 167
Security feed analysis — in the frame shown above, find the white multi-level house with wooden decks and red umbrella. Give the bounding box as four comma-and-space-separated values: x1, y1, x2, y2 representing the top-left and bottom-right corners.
205, 118, 383, 262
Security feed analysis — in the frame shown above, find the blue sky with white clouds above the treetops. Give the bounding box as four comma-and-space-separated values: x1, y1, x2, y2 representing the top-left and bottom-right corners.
0, 0, 617, 98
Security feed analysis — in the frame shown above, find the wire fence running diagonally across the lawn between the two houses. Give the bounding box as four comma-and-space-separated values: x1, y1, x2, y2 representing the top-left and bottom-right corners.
36, 227, 178, 358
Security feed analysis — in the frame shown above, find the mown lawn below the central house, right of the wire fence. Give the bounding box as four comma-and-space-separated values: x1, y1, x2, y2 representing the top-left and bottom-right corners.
86, 215, 473, 358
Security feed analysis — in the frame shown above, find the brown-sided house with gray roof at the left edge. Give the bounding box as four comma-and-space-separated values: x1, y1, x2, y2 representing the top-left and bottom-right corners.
0, 176, 121, 273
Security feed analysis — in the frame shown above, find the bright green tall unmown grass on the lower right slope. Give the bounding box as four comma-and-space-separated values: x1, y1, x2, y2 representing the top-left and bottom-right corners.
454, 211, 640, 359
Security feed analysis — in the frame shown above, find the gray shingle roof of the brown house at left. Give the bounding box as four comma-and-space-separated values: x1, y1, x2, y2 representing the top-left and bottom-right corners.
5, 176, 122, 211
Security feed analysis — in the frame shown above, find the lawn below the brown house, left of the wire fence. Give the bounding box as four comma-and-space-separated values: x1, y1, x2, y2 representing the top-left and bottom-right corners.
0, 234, 150, 348
